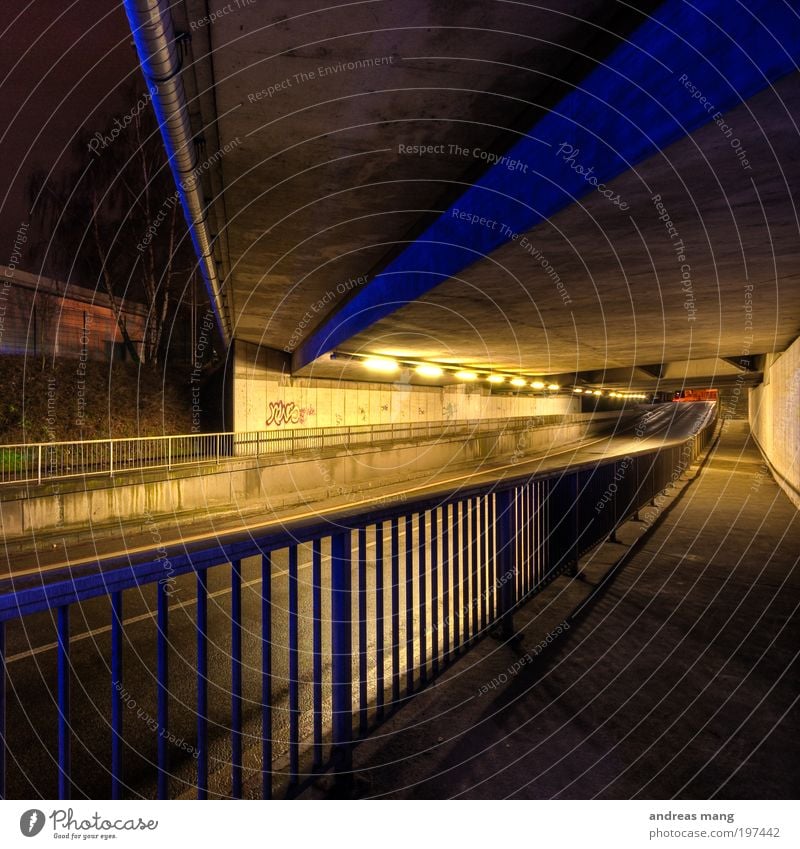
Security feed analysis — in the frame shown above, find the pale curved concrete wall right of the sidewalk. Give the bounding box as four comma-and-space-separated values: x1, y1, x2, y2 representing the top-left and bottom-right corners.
749, 338, 800, 508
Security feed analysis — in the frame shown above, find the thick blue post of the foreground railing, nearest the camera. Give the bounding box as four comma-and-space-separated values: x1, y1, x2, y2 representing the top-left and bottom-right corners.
331, 531, 353, 789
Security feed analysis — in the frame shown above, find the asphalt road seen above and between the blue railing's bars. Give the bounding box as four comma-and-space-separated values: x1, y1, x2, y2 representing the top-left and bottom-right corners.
0, 404, 705, 798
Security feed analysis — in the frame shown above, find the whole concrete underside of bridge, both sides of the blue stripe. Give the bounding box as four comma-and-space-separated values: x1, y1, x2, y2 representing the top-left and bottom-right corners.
174, 0, 800, 385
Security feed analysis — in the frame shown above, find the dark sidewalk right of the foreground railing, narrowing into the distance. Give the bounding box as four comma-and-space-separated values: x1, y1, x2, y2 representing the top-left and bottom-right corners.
332, 422, 800, 799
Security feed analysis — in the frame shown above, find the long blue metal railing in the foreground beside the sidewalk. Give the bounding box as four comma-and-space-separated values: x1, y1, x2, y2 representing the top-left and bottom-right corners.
0, 410, 716, 799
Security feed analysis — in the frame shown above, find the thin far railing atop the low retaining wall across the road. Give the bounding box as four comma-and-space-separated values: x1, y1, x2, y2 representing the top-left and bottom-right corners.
0, 413, 618, 485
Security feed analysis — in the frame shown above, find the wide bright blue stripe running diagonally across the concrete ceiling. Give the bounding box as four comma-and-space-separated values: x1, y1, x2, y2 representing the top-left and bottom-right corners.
293, 0, 800, 369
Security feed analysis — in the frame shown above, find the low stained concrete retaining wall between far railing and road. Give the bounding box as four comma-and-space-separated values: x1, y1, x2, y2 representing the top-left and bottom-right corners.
0, 416, 618, 551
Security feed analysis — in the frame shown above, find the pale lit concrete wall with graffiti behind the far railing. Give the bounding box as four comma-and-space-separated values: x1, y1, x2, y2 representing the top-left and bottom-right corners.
233, 342, 580, 431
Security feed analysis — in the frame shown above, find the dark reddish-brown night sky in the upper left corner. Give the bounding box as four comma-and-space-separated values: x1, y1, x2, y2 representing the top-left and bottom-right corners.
0, 0, 143, 271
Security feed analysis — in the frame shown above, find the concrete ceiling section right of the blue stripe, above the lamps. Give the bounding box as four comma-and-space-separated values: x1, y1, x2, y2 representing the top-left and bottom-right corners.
330, 74, 800, 374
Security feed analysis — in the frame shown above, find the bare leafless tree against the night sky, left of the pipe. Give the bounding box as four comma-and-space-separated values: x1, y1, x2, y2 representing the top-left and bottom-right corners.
28, 84, 203, 365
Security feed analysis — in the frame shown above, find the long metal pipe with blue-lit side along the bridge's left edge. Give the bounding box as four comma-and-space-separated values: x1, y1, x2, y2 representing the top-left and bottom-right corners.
124, 0, 231, 348
